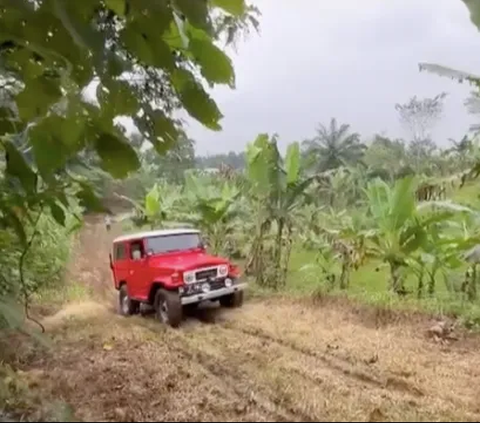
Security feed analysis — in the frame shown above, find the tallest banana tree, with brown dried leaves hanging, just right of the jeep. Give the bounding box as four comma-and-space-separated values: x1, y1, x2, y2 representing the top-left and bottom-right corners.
247, 134, 316, 288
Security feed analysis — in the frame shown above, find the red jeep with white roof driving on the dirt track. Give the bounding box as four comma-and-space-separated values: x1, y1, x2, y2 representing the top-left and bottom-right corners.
110, 229, 246, 327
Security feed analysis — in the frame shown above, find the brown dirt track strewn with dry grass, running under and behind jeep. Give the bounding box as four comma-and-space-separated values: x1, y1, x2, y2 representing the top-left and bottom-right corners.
31, 220, 480, 421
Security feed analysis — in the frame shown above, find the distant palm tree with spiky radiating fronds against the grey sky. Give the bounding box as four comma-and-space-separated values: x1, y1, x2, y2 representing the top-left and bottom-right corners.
303, 118, 366, 172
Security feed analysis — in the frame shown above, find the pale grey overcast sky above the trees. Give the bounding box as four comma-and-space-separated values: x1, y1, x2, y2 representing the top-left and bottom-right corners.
187, 0, 480, 154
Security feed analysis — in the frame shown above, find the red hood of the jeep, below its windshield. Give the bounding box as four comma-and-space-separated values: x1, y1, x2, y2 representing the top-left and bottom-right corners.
150, 251, 228, 271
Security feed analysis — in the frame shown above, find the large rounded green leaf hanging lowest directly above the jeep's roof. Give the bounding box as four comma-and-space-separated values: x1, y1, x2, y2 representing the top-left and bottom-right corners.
95, 132, 140, 178
